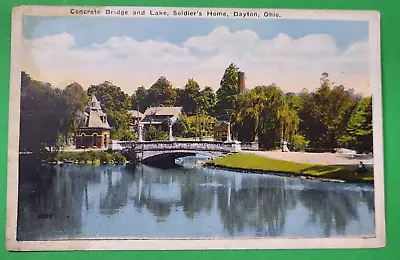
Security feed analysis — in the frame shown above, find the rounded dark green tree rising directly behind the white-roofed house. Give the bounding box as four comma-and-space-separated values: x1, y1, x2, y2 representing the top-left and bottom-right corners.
143, 76, 176, 109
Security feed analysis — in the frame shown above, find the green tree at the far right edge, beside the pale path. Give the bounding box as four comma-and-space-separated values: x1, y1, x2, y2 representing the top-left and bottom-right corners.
339, 96, 373, 153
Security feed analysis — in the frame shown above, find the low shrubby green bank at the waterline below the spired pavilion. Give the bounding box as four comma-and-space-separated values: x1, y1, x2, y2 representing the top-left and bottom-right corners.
43, 151, 127, 164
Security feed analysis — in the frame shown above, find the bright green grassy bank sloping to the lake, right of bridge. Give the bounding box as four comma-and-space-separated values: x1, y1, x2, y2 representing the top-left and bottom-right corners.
206, 153, 373, 182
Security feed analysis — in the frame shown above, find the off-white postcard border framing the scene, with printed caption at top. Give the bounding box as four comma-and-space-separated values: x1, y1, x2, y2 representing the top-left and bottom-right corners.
6, 6, 386, 251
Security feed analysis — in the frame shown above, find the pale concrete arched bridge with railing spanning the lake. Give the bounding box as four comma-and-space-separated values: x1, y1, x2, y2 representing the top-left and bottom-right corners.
110, 141, 241, 164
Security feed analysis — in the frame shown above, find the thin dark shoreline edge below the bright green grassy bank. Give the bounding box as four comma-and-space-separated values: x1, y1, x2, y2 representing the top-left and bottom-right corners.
203, 163, 374, 185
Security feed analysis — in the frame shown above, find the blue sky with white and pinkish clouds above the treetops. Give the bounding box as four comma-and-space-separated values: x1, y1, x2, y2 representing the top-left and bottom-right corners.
23, 16, 370, 95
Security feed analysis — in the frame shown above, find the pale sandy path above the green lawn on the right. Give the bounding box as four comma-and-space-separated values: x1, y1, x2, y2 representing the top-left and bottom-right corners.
243, 151, 374, 167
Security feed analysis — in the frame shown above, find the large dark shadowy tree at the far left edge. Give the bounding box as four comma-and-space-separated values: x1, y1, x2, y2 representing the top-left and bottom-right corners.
19, 72, 74, 154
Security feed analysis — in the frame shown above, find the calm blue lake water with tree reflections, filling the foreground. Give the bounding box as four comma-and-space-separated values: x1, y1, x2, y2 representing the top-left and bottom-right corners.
17, 155, 375, 240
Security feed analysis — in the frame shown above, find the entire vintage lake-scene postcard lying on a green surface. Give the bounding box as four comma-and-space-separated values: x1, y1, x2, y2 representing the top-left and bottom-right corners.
6, 6, 386, 251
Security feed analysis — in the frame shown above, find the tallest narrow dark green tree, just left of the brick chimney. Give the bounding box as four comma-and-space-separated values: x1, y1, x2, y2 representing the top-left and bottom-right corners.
215, 63, 240, 121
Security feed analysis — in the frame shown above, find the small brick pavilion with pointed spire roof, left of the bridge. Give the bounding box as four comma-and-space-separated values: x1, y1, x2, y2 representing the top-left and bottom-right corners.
75, 94, 111, 149
